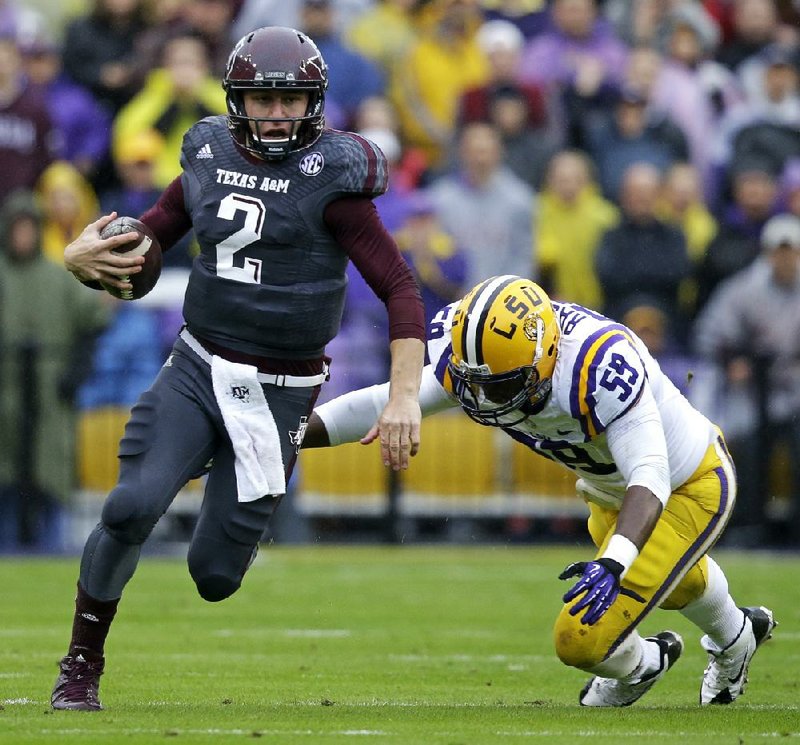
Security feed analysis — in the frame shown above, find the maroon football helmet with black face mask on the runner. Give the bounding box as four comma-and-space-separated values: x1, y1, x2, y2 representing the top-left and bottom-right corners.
222, 26, 328, 160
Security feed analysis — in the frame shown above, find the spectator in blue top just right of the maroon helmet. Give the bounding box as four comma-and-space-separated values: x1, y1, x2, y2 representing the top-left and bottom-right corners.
299, 0, 386, 128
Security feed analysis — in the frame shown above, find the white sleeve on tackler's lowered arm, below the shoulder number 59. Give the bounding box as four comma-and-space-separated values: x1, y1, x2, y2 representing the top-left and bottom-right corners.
606, 385, 672, 505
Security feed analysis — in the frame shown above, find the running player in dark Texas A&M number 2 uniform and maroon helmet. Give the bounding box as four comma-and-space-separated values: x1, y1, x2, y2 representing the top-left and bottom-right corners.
51, 27, 424, 710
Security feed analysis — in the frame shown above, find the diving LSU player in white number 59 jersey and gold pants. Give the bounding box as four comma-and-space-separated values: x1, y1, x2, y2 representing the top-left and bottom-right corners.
304, 276, 776, 706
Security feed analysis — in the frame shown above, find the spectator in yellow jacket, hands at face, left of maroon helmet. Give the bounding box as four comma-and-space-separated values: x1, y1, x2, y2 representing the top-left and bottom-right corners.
113, 35, 225, 188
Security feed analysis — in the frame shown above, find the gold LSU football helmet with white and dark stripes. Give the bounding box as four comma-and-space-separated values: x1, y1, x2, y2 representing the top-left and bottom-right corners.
447, 275, 561, 426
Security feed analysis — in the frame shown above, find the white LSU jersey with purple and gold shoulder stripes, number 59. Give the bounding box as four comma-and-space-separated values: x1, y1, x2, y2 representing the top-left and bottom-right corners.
420, 302, 717, 508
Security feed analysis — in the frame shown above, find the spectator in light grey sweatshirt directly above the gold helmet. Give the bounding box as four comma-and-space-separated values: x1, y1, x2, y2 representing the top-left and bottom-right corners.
429, 122, 536, 286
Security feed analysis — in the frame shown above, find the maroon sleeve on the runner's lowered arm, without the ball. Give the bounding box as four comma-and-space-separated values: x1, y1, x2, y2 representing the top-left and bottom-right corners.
324, 197, 425, 342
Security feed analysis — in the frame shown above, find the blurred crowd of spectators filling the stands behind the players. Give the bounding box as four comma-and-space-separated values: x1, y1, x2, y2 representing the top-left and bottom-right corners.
0, 0, 800, 545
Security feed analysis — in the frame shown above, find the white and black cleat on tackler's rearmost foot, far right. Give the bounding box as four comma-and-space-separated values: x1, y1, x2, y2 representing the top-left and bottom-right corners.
700, 606, 778, 706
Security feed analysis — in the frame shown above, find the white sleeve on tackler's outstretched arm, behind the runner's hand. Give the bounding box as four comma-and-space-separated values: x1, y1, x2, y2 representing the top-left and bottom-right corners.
314, 365, 458, 445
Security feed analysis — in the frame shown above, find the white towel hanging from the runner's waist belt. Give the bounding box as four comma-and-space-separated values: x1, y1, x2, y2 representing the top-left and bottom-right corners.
211, 355, 286, 502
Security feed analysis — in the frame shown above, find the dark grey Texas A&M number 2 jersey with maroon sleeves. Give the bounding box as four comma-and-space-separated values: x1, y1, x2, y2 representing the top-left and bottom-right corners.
143, 117, 424, 359
